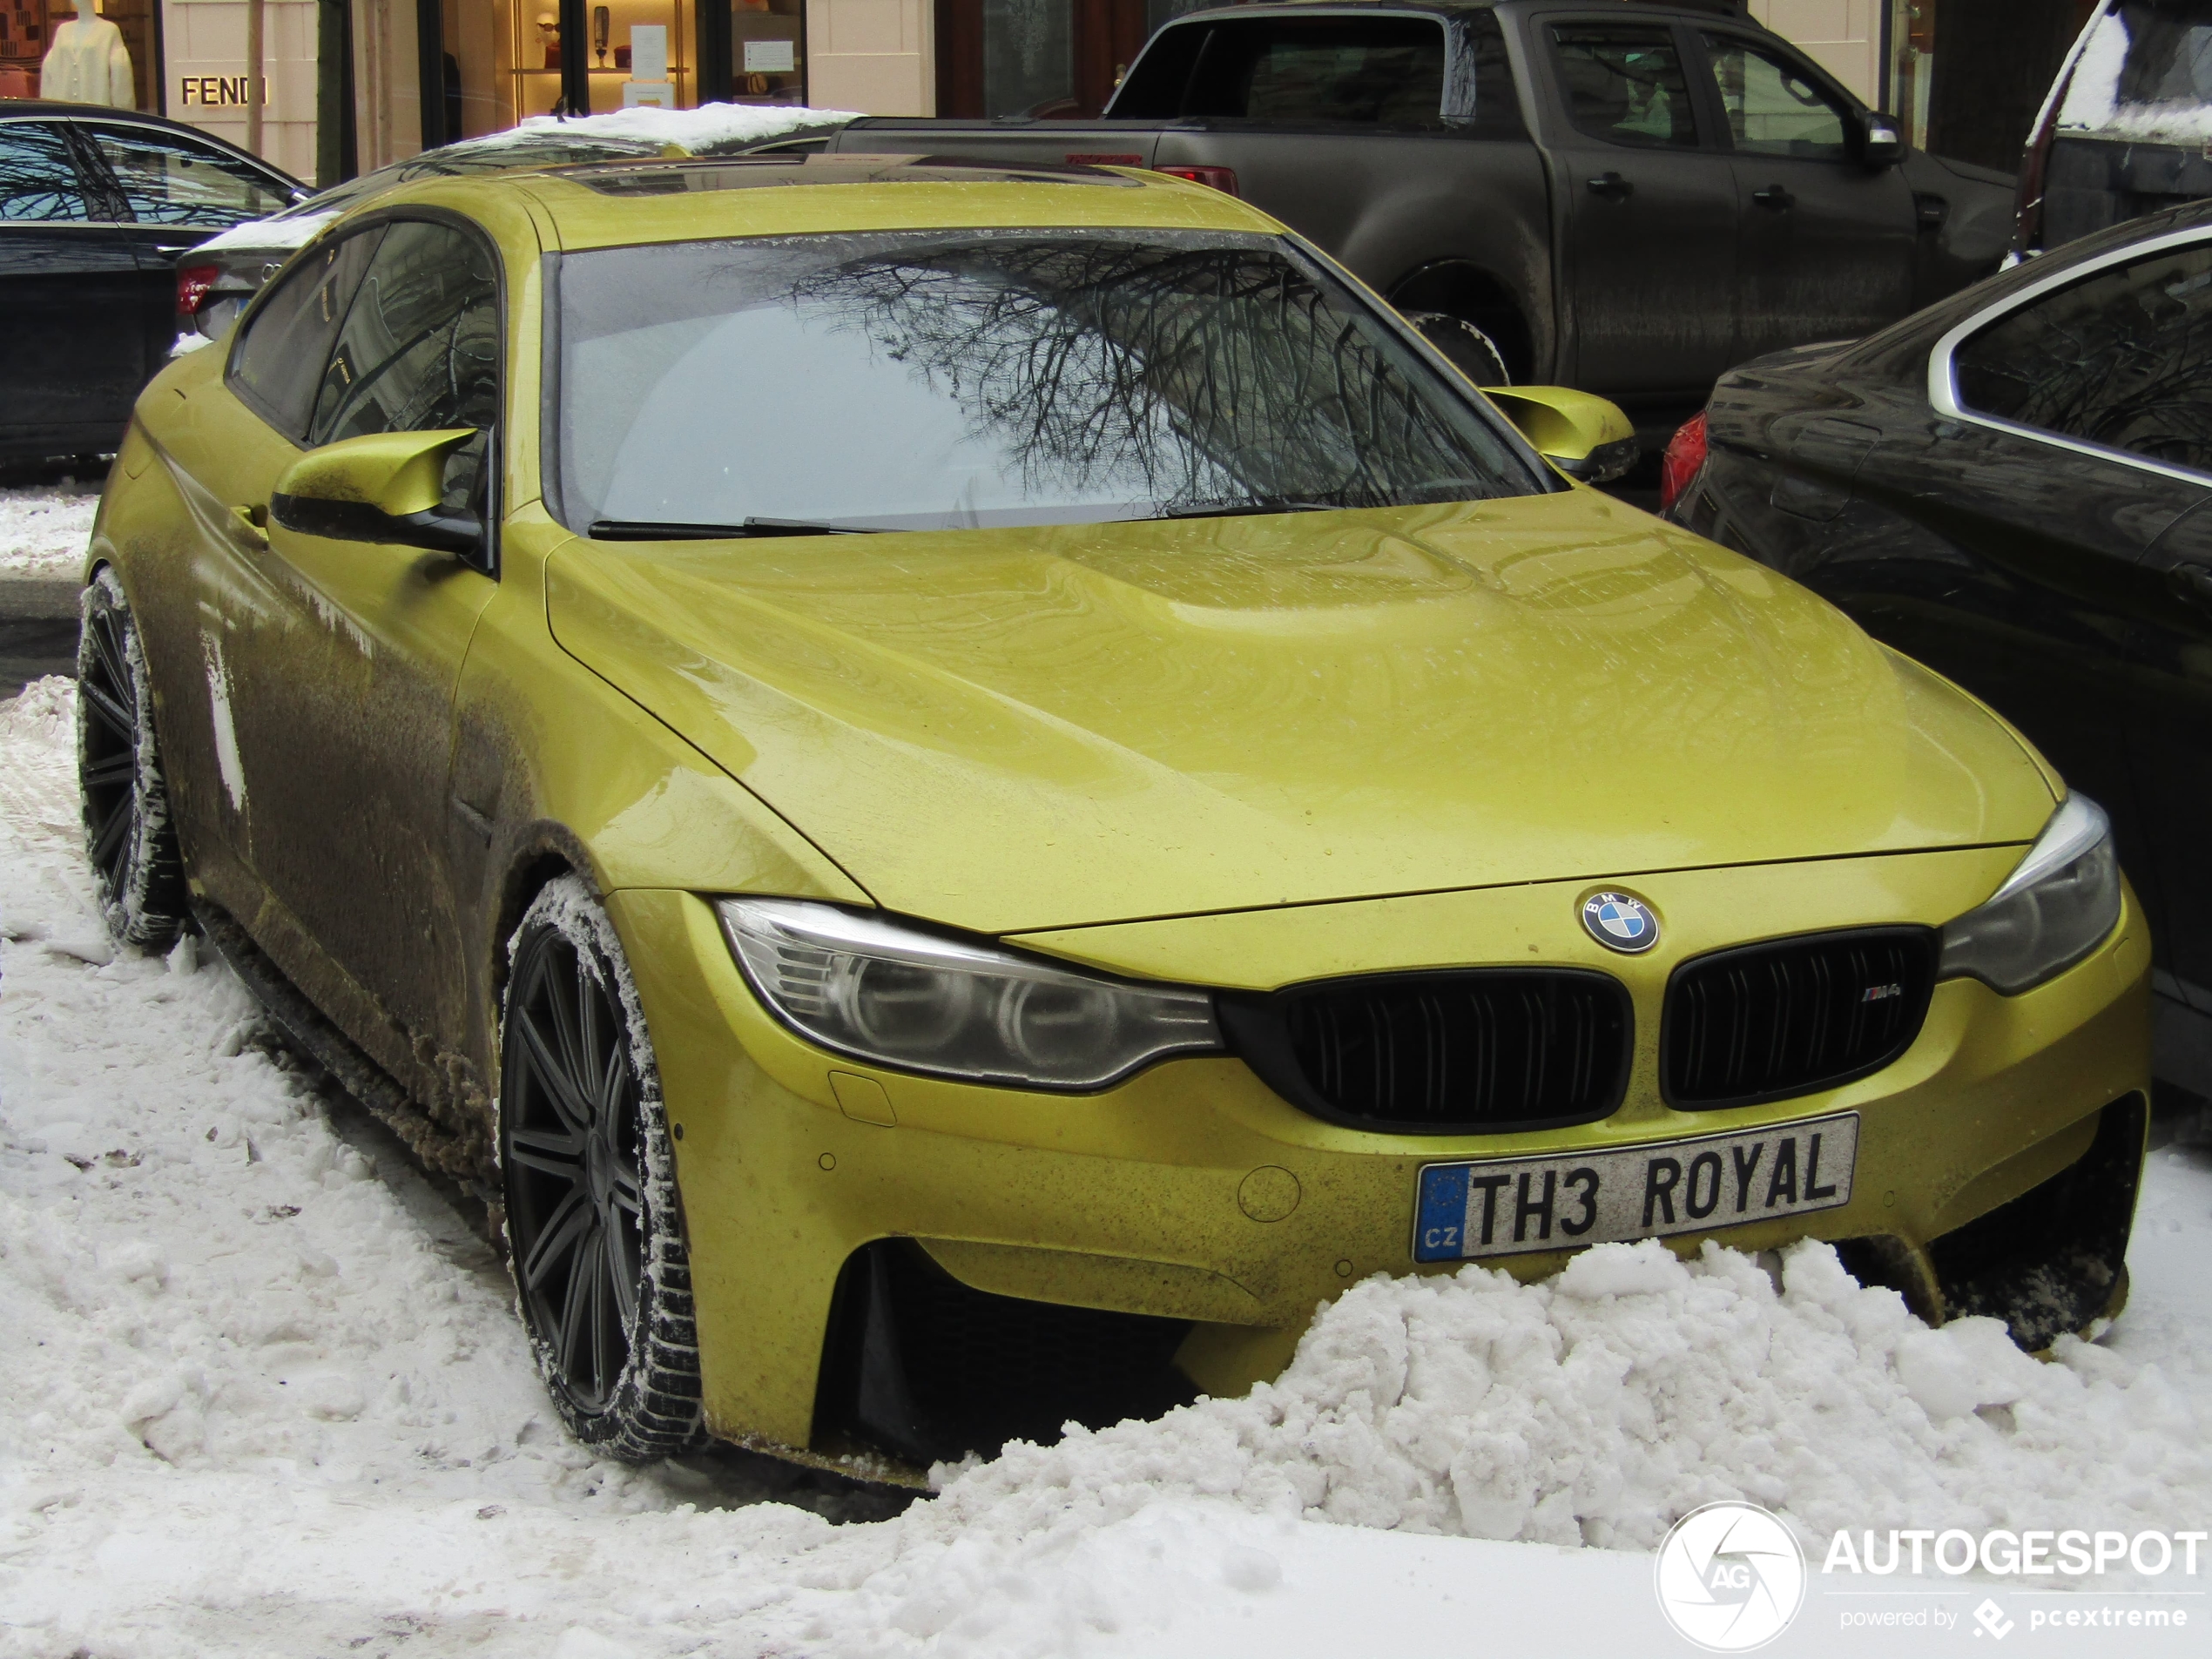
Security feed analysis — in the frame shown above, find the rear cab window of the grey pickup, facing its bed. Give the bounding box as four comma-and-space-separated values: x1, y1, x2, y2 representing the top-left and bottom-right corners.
1181, 17, 1445, 128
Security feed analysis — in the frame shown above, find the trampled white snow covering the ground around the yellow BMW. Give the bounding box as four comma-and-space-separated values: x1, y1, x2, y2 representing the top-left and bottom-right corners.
0, 679, 2212, 1659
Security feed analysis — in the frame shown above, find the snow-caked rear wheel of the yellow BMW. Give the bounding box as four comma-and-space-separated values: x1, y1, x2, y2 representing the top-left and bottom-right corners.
78, 569, 185, 951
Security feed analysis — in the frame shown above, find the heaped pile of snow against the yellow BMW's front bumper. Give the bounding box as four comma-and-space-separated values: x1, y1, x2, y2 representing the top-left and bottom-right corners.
938, 1243, 2212, 1548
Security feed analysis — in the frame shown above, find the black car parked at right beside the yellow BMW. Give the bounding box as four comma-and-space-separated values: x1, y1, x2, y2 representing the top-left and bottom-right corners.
1668, 201, 2212, 1095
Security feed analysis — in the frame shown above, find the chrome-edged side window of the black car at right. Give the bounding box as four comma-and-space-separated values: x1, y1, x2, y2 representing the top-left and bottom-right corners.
1951, 243, 2212, 474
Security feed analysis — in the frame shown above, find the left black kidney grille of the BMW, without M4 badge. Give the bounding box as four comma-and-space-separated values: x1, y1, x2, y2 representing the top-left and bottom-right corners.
1219, 969, 1633, 1135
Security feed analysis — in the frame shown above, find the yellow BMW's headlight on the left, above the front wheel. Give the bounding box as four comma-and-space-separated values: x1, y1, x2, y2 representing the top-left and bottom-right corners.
714, 898, 1221, 1089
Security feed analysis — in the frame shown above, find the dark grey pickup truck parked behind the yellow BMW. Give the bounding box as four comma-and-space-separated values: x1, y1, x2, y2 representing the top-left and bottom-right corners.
822, 0, 2013, 434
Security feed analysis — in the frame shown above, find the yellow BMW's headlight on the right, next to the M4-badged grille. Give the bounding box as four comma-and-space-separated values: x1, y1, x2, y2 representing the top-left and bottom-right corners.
1936, 794, 2119, 995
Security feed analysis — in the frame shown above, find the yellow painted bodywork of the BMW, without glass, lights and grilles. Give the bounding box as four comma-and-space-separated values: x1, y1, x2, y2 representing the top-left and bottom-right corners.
93, 156, 2150, 1447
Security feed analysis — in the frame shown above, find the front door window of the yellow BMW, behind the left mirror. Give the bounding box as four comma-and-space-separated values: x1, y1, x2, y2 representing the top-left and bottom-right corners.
307, 221, 500, 517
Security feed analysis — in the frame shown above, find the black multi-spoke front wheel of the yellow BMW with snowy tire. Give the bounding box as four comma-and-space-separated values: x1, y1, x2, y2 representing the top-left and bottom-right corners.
498, 876, 701, 1462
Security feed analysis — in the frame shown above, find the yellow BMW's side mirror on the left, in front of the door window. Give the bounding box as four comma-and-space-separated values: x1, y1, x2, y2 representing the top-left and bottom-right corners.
270, 427, 484, 557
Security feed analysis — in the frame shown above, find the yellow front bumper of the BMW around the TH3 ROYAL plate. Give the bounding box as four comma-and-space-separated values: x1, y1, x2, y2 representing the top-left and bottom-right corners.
609, 847, 2150, 1447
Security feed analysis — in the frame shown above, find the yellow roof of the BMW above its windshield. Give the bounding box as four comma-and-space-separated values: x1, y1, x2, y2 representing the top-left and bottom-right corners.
391, 152, 1283, 250
